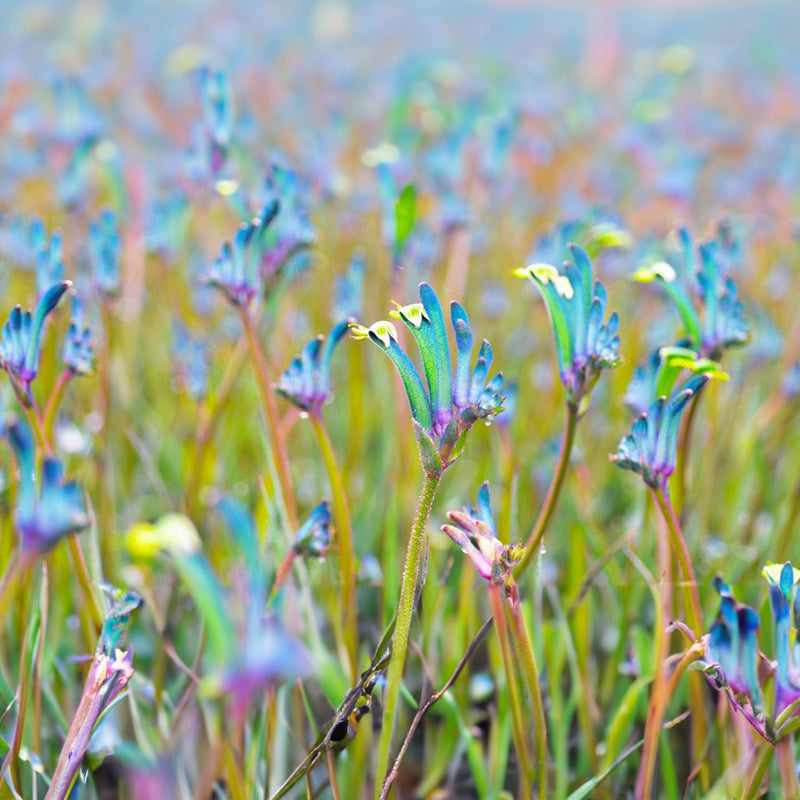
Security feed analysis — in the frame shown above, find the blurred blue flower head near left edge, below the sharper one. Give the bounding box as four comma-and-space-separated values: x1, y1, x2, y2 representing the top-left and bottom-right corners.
8, 420, 89, 553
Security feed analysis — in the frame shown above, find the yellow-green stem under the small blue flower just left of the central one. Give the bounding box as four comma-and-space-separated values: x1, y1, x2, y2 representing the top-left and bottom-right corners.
311, 413, 358, 681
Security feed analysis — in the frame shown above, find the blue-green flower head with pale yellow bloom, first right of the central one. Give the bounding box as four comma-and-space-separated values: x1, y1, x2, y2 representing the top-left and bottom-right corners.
514, 244, 620, 409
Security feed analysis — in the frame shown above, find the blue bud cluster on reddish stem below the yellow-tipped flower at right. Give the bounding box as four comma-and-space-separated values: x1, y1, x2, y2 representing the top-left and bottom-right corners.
611, 374, 709, 489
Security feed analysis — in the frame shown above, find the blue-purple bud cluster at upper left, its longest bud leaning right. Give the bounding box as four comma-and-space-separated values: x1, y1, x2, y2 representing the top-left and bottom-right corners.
204, 200, 278, 307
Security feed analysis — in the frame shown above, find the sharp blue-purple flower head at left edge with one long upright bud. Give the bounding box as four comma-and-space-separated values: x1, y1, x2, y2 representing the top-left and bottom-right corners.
0, 281, 72, 397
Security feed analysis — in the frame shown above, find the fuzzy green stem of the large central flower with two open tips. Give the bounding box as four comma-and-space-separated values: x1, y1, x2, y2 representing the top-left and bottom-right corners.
375, 472, 441, 800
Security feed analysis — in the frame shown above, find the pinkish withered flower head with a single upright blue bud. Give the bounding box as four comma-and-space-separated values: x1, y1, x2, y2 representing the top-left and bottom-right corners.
442, 481, 523, 584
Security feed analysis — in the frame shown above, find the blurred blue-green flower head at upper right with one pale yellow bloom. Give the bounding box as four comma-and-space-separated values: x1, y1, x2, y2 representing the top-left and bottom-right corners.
633, 228, 750, 361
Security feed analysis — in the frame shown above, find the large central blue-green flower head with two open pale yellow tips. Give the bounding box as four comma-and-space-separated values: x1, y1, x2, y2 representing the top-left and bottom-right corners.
351, 283, 503, 466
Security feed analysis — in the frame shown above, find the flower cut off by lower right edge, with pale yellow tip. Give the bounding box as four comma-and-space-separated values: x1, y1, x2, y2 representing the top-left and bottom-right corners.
764, 561, 800, 717
